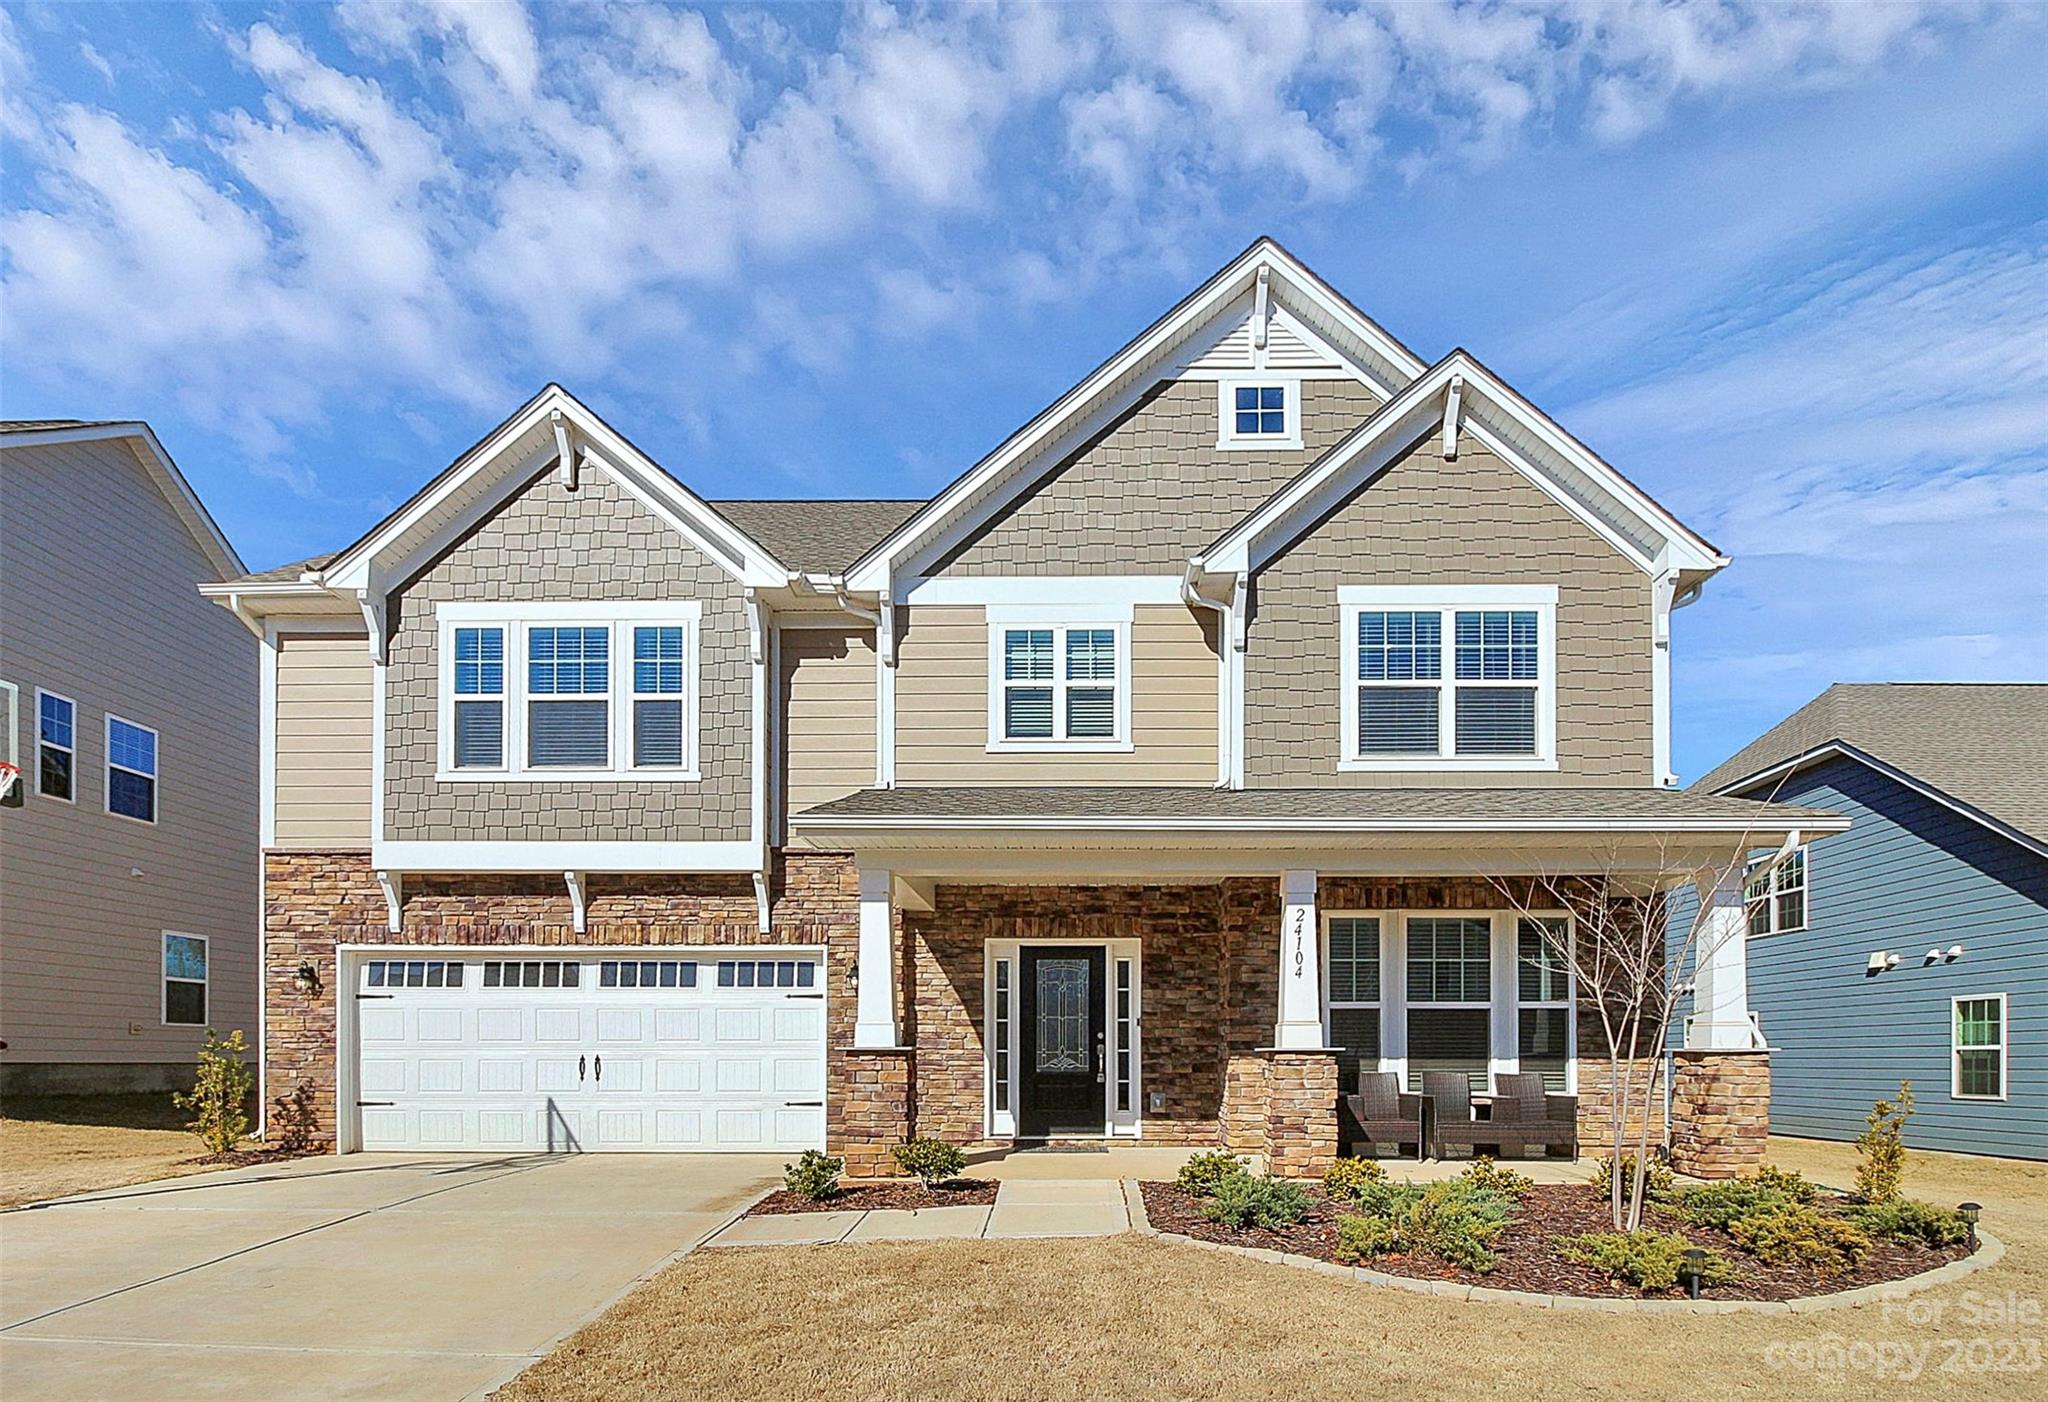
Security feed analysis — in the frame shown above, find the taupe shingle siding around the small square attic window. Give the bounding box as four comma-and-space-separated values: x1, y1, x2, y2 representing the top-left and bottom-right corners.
930, 379, 1378, 575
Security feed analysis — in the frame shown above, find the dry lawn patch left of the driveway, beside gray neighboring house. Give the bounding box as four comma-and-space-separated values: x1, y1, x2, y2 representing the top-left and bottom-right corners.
0, 1095, 207, 1208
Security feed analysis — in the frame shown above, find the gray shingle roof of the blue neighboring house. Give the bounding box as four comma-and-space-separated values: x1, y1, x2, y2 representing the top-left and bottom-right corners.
1694, 682, 2048, 839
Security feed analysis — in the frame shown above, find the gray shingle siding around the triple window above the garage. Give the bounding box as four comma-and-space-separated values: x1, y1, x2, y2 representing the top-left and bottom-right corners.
385, 467, 752, 841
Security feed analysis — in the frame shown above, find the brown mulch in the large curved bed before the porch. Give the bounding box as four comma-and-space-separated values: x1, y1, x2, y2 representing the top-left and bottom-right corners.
1139, 1183, 1970, 1300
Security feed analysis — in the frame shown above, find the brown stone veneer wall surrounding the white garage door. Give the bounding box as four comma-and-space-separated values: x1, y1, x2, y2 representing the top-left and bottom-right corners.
262, 851, 864, 1148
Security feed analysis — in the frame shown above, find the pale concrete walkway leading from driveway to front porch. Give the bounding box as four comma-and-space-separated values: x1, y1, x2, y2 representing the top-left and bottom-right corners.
705, 1179, 1130, 1246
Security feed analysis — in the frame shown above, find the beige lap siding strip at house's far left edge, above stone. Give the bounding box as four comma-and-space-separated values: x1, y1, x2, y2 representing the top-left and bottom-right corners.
270, 632, 377, 851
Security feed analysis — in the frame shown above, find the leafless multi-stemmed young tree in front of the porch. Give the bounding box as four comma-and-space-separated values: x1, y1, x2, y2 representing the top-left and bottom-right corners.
1485, 831, 1798, 1232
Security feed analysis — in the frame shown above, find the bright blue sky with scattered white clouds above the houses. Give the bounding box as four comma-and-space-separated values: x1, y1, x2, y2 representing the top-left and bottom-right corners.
0, 0, 2048, 778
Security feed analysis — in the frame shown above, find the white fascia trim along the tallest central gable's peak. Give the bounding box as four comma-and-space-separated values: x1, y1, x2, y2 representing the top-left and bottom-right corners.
846, 239, 1423, 592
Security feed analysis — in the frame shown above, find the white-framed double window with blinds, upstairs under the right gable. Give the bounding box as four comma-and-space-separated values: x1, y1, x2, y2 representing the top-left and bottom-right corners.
1337, 585, 1556, 770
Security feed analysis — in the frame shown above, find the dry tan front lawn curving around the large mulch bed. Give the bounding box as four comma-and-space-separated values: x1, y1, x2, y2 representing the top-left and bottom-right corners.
496, 1140, 2048, 1402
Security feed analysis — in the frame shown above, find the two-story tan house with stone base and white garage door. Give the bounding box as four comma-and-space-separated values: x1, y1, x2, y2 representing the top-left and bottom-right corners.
209, 239, 1841, 1173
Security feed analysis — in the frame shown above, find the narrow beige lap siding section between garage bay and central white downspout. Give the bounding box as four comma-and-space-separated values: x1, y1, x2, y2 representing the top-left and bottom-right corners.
776, 628, 874, 813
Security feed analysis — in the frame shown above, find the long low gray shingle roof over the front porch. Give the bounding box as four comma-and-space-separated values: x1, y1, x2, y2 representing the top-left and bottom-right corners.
793, 786, 1829, 825
